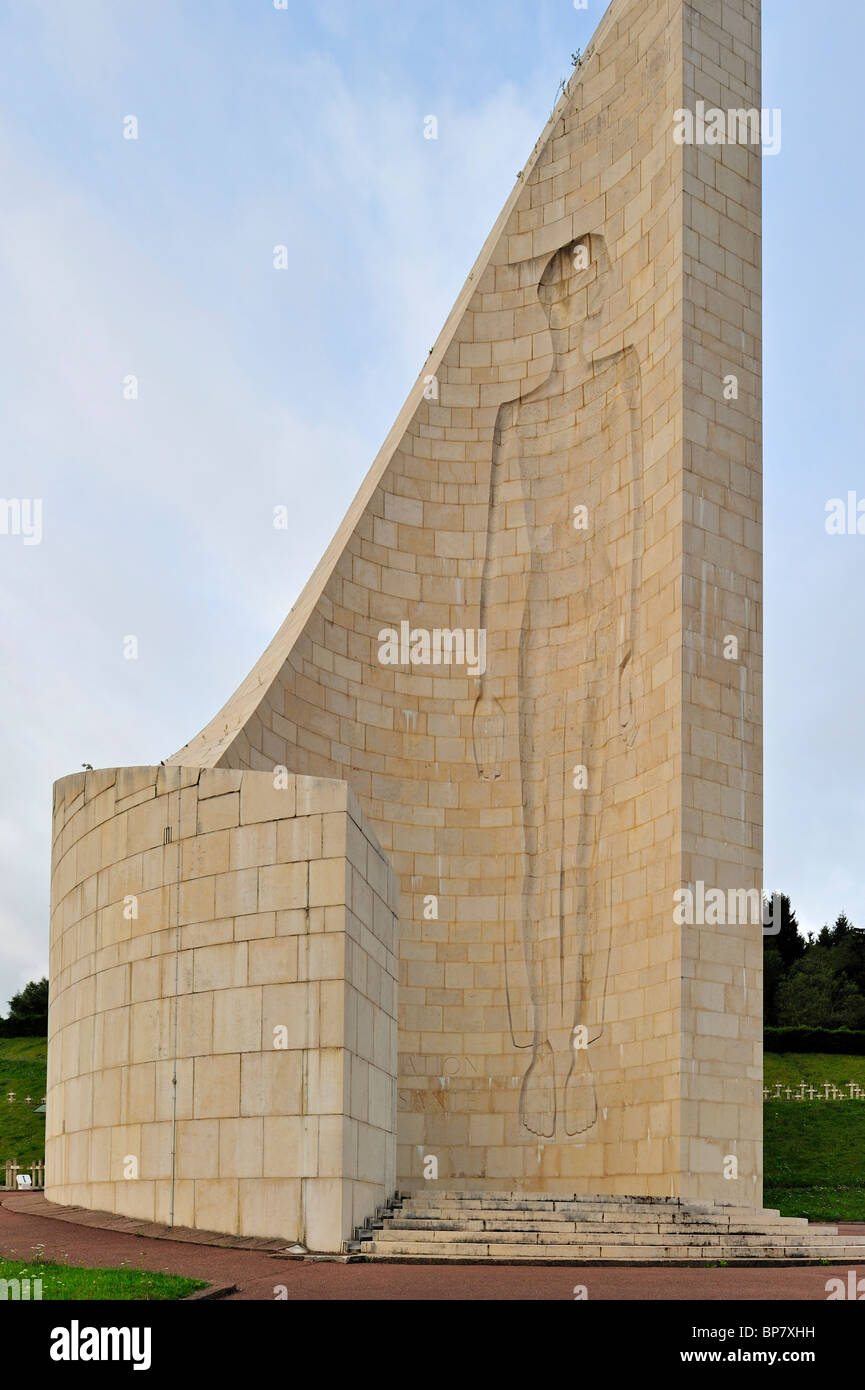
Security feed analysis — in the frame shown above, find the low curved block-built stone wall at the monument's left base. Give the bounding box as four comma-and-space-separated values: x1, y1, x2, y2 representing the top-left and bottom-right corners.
46, 767, 396, 1251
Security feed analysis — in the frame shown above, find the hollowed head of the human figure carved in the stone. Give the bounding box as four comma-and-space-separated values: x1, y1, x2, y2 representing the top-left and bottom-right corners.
538, 232, 612, 361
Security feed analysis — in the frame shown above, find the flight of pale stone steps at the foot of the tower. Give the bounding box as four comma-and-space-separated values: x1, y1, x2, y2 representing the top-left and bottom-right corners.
349, 1191, 865, 1265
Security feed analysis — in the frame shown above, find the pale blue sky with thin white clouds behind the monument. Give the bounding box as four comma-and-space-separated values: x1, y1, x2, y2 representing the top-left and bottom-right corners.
0, 0, 865, 1012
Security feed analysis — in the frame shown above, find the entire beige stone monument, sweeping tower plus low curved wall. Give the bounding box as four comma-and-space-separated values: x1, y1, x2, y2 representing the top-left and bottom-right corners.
47, 0, 762, 1250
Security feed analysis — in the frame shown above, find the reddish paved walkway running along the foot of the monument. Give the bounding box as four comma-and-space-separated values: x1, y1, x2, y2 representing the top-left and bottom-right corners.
0, 1193, 865, 1302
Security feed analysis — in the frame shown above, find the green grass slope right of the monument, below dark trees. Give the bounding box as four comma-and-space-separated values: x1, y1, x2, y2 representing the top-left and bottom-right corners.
763, 1052, 865, 1222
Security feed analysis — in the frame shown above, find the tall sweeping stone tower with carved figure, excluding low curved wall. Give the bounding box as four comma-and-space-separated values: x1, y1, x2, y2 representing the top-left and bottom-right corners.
162, 0, 761, 1204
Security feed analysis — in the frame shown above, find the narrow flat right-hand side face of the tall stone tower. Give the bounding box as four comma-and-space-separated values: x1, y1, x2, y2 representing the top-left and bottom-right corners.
681, 0, 762, 1205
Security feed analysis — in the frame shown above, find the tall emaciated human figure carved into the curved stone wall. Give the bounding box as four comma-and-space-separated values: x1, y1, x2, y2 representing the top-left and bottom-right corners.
473, 234, 642, 1138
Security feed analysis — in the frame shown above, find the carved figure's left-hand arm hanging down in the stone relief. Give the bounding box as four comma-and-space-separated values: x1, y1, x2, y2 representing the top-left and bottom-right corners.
471, 403, 519, 781
